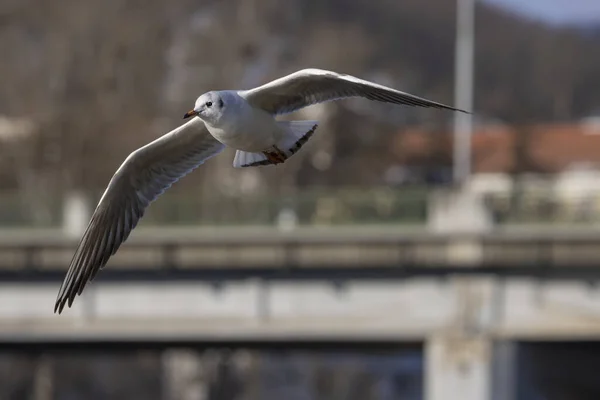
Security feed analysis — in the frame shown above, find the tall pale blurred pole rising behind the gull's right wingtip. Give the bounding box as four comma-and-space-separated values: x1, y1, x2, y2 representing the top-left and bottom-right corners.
453, 0, 476, 183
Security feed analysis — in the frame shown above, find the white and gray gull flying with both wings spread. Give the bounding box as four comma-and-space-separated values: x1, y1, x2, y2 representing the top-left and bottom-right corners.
54, 69, 466, 314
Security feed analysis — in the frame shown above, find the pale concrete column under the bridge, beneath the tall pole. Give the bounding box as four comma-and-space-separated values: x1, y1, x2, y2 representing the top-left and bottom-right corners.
425, 335, 492, 400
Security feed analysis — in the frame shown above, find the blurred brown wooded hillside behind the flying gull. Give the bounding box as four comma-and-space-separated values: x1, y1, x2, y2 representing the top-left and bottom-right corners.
0, 0, 600, 211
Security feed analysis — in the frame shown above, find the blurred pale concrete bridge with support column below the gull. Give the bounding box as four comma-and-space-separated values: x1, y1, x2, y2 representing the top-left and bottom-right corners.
0, 227, 600, 400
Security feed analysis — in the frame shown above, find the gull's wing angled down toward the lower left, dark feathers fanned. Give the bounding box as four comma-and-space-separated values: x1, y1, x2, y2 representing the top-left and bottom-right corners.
54, 118, 225, 314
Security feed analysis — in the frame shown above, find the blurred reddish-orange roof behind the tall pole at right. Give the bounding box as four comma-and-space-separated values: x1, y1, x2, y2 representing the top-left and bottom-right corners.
392, 123, 600, 172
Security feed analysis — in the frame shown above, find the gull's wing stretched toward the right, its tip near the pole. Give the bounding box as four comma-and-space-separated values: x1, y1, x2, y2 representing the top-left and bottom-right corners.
238, 69, 466, 114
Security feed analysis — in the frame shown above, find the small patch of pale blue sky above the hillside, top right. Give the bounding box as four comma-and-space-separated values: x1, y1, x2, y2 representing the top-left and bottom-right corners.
484, 0, 600, 23
